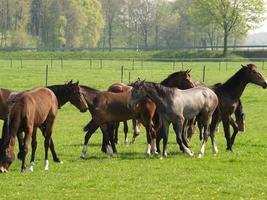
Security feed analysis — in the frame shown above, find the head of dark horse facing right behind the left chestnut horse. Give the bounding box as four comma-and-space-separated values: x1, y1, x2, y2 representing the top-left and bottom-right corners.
65, 80, 88, 112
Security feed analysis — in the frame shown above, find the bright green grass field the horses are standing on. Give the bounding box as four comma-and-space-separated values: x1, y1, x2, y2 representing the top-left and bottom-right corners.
0, 60, 267, 200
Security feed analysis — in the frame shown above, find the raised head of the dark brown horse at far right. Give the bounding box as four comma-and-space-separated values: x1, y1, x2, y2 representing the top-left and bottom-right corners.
241, 64, 267, 89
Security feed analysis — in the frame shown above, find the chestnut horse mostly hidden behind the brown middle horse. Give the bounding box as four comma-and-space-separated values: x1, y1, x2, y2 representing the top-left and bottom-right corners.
108, 83, 140, 144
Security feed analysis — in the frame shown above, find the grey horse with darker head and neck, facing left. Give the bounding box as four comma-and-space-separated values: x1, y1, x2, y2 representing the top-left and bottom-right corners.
129, 80, 218, 157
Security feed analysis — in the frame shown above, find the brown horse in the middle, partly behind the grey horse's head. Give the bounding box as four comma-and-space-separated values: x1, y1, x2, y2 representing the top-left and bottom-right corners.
81, 86, 159, 158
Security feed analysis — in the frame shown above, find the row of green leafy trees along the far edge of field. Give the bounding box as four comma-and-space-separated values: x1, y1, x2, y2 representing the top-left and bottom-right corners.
0, 0, 264, 52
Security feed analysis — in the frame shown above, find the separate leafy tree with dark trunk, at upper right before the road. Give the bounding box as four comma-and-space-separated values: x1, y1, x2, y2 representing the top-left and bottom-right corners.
194, 0, 264, 56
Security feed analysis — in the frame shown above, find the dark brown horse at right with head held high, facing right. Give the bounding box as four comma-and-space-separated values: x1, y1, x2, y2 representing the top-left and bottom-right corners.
210, 64, 267, 150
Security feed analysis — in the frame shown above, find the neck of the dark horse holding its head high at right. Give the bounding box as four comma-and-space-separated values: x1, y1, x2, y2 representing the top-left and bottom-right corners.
218, 71, 248, 101
